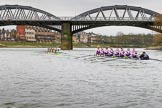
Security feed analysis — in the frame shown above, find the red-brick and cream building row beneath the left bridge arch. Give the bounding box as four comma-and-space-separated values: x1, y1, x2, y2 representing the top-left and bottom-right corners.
16, 25, 55, 42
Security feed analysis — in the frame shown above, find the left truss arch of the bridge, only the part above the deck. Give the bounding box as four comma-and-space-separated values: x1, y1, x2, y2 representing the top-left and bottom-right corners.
0, 5, 60, 20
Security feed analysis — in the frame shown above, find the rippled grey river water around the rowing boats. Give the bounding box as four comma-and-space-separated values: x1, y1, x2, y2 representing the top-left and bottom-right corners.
0, 48, 162, 108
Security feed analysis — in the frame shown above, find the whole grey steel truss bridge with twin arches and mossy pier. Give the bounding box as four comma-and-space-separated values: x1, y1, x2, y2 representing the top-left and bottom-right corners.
0, 5, 162, 49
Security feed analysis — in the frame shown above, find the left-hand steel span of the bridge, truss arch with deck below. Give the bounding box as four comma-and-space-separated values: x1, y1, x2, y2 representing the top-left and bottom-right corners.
0, 5, 61, 32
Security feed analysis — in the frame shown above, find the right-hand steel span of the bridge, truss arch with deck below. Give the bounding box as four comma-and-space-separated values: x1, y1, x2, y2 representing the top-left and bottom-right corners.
71, 5, 162, 33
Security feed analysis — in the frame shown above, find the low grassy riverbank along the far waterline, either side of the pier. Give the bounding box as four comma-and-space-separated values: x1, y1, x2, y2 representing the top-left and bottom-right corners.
0, 41, 152, 48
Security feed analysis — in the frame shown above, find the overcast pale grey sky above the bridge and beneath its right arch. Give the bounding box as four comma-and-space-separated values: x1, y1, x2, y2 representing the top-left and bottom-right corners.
0, 0, 162, 35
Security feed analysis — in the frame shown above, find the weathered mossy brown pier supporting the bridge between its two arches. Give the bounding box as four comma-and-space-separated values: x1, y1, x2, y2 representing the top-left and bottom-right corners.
61, 22, 73, 50
